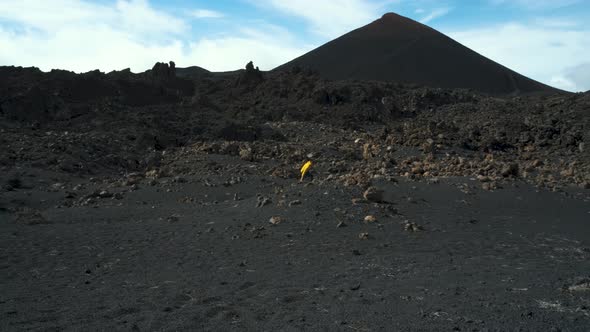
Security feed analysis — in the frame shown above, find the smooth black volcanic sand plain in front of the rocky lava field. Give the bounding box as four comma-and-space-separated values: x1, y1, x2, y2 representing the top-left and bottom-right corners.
0, 155, 590, 331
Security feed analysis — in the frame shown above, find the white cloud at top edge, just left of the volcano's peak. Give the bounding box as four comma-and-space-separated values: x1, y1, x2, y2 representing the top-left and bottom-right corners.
257, 0, 396, 38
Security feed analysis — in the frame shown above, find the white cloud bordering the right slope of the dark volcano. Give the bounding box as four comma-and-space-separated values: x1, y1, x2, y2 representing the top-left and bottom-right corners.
448, 23, 590, 91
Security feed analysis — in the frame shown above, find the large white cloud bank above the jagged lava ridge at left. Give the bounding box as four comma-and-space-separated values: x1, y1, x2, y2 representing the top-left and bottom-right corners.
0, 0, 308, 72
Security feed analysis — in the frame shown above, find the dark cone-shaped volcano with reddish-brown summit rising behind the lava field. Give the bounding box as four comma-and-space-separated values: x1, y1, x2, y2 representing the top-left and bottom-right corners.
276, 13, 559, 94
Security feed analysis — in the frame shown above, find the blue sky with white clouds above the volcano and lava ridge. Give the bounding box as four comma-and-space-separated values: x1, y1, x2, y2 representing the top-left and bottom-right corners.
0, 0, 590, 92
